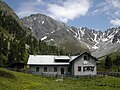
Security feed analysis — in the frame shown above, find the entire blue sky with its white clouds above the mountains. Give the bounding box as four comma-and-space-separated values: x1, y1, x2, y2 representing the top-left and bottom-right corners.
3, 0, 120, 31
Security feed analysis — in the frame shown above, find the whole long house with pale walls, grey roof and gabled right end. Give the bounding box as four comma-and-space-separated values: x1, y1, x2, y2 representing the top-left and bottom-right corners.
27, 52, 97, 76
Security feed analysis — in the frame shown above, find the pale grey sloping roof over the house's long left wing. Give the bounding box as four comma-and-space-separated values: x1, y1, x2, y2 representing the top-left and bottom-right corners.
27, 55, 70, 65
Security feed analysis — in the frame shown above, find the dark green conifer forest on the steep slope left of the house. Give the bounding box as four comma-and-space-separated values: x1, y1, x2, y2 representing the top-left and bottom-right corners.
0, 10, 65, 67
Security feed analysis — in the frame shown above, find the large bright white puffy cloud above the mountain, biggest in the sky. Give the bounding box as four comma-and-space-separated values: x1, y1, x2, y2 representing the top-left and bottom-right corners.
47, 0, 90, 23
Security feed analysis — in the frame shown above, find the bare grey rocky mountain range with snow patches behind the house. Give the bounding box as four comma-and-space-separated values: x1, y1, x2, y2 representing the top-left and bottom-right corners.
21, 14, 120, 57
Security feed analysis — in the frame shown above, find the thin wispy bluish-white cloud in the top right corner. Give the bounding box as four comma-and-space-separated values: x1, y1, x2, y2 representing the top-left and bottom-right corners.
92, 0, 120, 15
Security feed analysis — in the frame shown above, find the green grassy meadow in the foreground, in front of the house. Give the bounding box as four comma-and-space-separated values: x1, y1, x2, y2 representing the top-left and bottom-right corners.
0, 69, 120, 90
